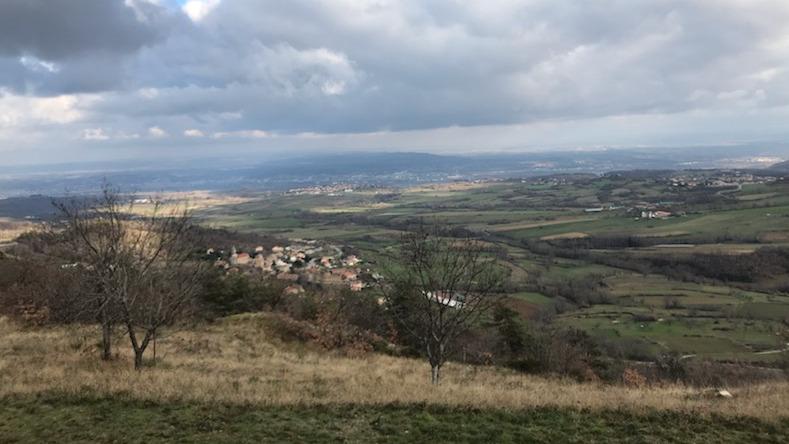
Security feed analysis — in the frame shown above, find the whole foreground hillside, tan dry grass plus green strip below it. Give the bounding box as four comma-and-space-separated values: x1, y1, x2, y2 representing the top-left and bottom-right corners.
0, 314, 789, 442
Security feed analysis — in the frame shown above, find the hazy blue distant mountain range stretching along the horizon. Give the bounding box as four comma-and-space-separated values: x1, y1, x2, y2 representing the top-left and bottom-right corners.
0, 147, 789, 198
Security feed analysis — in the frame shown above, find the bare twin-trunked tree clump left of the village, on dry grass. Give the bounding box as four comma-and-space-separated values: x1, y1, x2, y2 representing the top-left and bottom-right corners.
57, 184, 208, 369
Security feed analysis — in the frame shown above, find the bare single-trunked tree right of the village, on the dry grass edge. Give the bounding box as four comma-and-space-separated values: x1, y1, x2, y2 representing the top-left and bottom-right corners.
383, 222, 502, 384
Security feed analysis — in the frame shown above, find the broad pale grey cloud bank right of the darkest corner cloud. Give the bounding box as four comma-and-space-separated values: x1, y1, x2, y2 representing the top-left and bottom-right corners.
97, 0, 787, 132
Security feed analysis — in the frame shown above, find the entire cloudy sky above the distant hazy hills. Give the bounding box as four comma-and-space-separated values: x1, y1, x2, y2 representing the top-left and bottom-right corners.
0, 0, 789, 164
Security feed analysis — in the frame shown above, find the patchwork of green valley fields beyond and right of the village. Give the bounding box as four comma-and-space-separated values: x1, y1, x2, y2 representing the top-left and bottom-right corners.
189, 173, 789, 363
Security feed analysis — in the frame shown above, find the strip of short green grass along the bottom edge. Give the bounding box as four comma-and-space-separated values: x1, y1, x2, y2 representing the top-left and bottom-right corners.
0, 396, 789, 443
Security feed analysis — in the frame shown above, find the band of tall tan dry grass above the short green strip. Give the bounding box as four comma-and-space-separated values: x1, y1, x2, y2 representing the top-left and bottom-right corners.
0, 315, 789, 420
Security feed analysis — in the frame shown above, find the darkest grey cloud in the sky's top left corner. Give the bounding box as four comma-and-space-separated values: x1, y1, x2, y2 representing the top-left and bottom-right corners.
0, 0, 183, 96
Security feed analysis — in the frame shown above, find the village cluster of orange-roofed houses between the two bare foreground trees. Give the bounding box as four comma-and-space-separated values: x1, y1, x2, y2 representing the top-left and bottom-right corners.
206, 240, 370, 294
